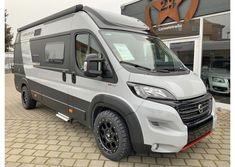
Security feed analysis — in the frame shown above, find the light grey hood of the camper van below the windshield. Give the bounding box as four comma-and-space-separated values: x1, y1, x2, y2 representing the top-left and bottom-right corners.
129, 72, 207, 100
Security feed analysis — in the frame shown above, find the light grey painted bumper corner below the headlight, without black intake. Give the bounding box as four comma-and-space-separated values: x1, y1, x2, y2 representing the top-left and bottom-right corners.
137, 100, 187, 152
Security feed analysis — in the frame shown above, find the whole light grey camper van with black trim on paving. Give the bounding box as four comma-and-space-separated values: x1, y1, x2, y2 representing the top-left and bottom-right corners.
14, 5, 216, 160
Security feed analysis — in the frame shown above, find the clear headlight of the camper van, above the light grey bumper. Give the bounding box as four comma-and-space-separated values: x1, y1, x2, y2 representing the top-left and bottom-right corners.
128, 83, 175, 100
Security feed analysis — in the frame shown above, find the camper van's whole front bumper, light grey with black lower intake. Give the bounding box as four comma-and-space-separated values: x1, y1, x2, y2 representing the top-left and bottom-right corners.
137, 94, 216, 153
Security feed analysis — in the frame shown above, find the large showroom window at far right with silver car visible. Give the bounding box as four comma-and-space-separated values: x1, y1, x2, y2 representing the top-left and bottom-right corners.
201, 14, 230, 103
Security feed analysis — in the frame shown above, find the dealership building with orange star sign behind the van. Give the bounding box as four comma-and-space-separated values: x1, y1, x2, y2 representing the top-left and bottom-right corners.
121, 0, 230, 104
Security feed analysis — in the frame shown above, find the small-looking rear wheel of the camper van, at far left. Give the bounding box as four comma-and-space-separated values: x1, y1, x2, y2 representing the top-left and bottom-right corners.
21, 86, 37, 110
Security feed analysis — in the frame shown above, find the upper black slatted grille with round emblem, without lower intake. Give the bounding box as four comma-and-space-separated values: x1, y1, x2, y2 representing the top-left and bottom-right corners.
176, 94, 212, 125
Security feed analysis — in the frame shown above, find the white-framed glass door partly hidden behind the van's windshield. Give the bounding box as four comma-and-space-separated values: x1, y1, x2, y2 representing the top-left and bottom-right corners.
164, 38, 201, 76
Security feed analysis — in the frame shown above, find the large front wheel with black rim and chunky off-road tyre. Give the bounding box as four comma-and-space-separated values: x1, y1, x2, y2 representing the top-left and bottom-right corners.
94, 110, 131, 161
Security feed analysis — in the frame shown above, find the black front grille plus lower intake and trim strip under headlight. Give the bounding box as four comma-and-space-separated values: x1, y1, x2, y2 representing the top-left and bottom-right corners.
150, 93, 213, 143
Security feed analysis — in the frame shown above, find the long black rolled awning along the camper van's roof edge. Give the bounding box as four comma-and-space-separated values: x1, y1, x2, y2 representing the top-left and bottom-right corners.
17, 4, 83, 32
